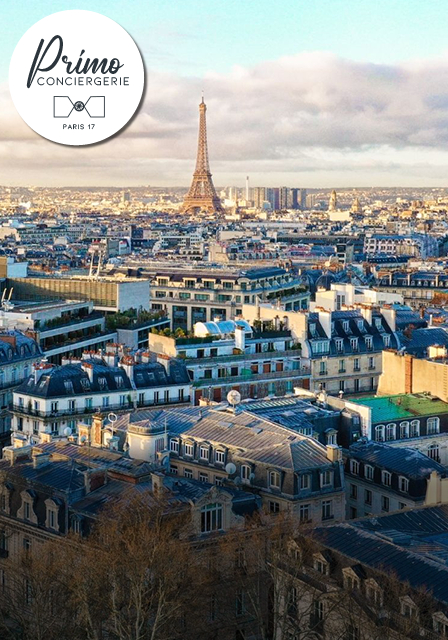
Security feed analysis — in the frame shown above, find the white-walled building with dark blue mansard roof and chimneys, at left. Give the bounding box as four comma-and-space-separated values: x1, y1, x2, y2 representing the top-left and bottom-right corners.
12, 345, 191, 444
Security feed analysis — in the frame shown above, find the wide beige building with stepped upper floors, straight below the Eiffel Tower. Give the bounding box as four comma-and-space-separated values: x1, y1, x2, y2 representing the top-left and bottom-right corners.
147, 267, 309, 330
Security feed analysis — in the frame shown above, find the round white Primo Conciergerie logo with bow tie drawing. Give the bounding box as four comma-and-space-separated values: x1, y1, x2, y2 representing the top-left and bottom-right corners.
9, 10, 144, 146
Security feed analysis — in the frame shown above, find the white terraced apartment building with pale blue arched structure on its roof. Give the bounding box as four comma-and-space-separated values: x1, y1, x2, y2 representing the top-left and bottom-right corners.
149, 319, 309, 404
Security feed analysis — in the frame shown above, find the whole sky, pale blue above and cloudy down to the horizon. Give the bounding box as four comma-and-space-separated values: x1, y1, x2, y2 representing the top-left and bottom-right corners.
0, 0, 448, 188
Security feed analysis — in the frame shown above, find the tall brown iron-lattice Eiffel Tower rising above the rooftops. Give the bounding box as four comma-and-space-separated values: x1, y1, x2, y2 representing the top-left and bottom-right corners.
183, 97, 224, 213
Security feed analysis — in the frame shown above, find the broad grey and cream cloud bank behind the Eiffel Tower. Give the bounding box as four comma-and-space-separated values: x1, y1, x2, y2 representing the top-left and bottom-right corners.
0, 52, 448, 186
